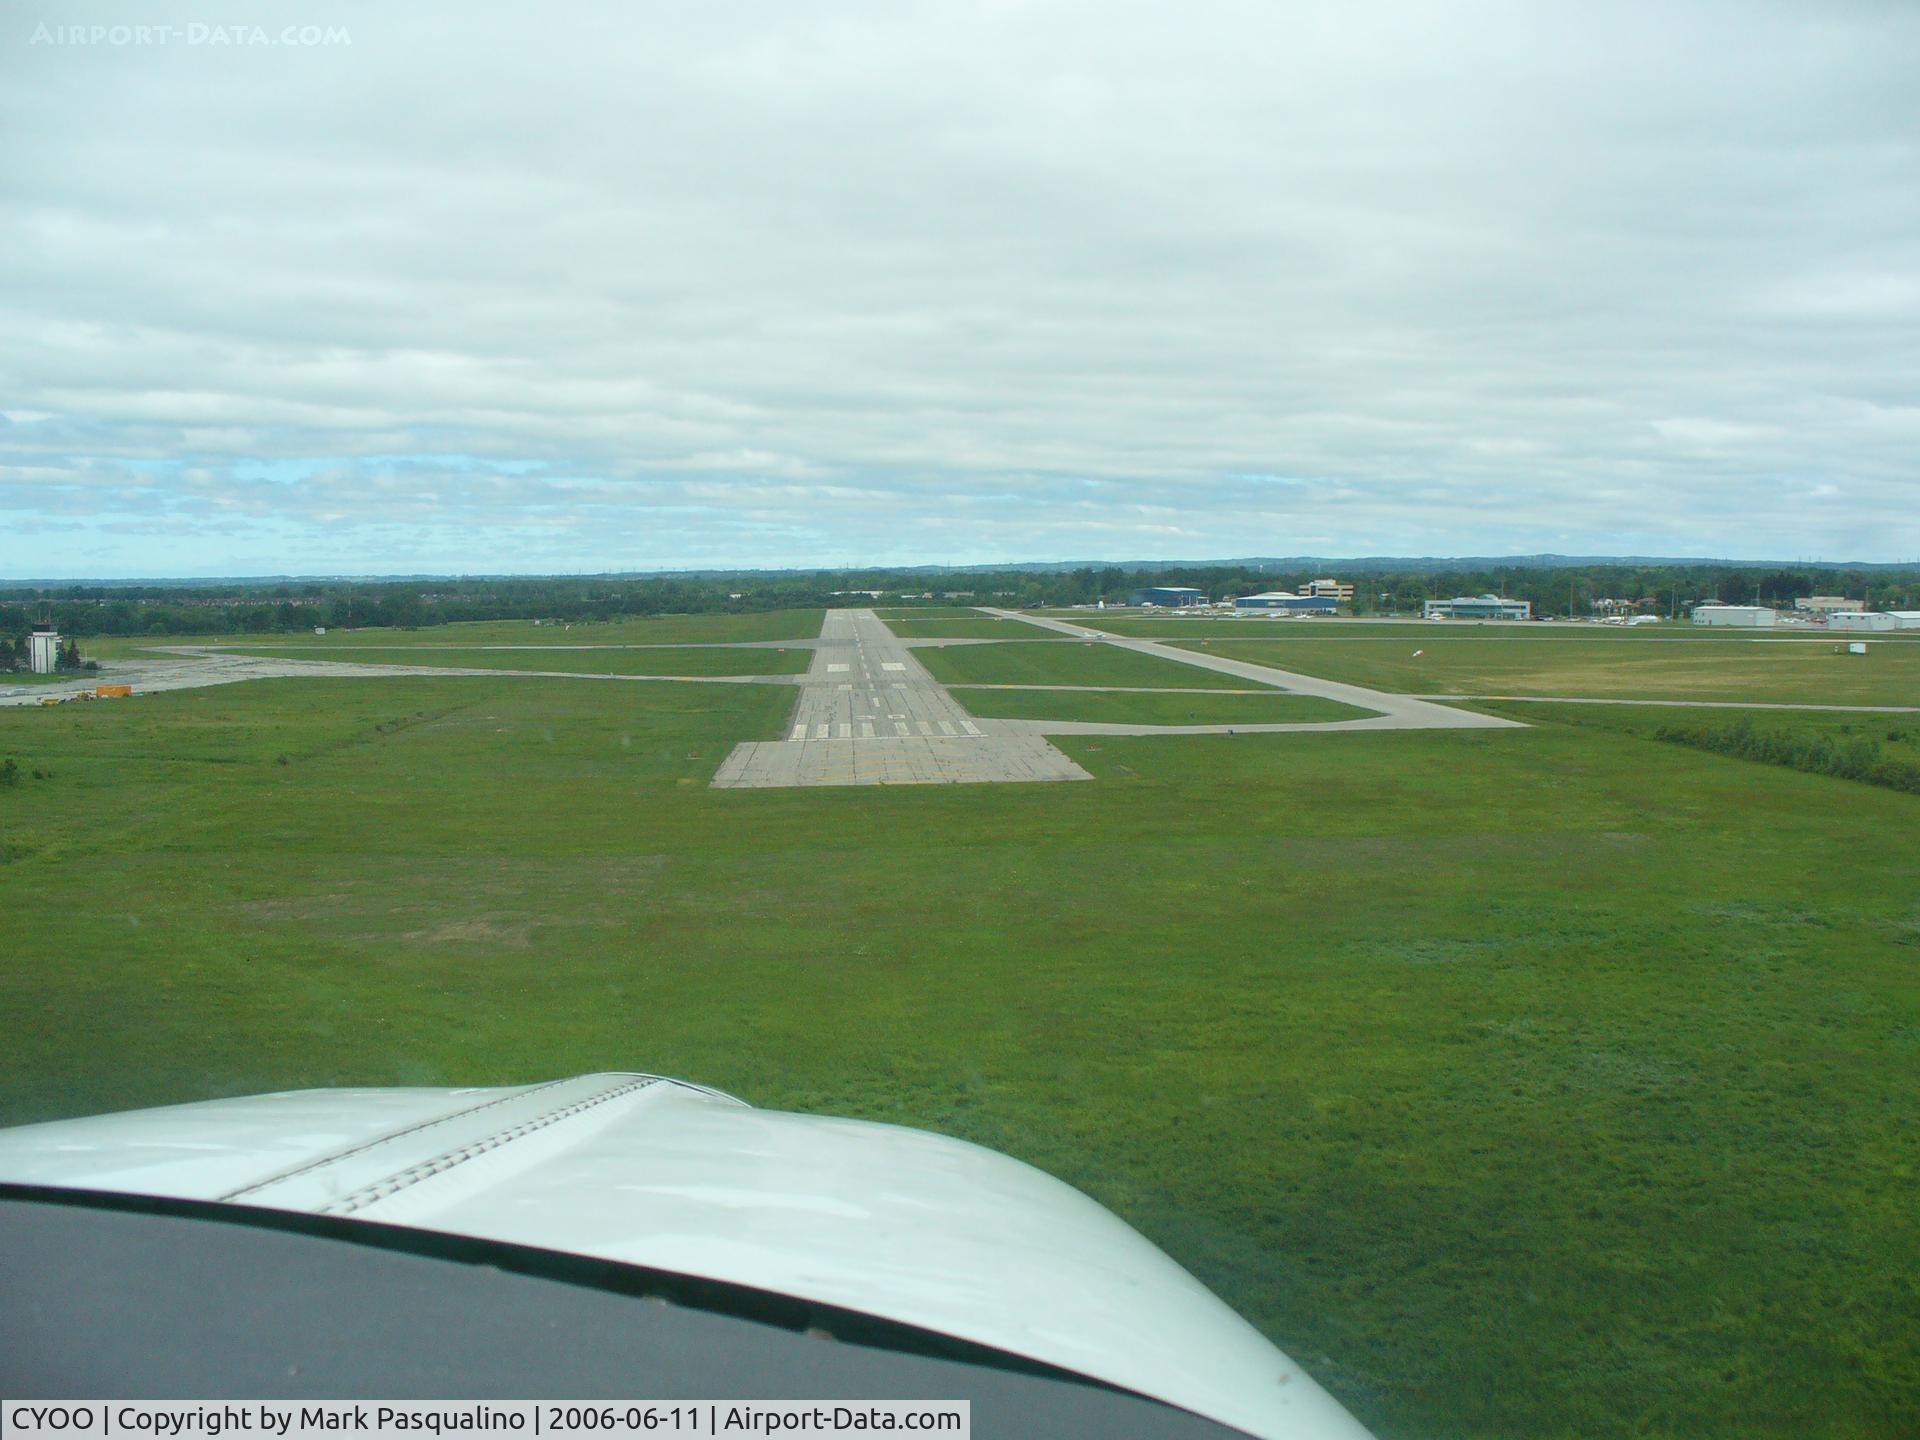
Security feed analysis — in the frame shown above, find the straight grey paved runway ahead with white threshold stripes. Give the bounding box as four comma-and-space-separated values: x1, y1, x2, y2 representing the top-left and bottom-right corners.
712, 611, 1092, 789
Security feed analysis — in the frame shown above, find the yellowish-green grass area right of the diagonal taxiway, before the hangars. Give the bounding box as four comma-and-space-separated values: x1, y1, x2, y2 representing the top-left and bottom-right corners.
1177, 626, 1920, 705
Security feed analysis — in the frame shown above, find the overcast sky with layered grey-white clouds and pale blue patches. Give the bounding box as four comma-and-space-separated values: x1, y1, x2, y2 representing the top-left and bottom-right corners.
0, 0, 1920, 576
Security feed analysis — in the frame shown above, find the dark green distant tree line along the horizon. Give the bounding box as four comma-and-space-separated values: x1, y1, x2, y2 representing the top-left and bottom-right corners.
0, 564, 1920, 636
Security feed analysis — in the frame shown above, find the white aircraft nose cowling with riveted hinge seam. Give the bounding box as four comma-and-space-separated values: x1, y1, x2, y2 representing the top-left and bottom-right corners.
0, 1075, 1367, 1440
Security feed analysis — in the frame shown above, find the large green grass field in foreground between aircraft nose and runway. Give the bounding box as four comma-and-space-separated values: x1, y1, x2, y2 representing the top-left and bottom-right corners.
0, 679, 1920, 1440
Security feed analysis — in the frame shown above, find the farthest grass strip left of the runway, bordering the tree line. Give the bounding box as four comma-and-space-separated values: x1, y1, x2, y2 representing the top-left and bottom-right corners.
81, 611, 826, 659
